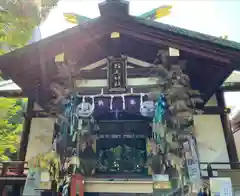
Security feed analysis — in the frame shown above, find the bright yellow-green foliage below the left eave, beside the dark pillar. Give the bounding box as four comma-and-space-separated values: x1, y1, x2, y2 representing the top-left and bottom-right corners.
0, 98, 27, 160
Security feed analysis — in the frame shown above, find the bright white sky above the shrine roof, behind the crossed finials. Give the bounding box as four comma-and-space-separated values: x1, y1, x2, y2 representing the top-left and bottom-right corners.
41, 0, 240, 42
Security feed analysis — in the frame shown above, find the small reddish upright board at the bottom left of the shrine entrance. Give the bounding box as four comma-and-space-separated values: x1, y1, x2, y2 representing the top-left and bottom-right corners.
70, 174, 84, 196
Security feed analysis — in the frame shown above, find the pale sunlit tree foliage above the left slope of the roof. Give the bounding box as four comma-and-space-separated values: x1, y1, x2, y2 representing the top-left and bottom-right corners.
0, 0, 58, 55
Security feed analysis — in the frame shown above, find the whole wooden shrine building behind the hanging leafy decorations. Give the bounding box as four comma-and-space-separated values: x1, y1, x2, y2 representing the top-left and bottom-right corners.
0, 1, 240, 193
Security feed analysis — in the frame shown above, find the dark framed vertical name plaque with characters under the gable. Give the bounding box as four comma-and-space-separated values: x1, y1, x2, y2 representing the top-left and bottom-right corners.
108, 57, 127, 92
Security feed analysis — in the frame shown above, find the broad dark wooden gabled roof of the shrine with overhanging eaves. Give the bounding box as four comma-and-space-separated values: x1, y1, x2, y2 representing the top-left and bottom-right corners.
0, 3, 239, 111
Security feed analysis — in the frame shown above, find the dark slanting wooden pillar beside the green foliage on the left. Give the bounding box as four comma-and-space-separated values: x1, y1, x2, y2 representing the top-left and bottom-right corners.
19, 99, 34, 161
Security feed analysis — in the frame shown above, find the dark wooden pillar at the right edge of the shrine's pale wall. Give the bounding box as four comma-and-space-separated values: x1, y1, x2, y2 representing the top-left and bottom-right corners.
216, 90, 239, 169
